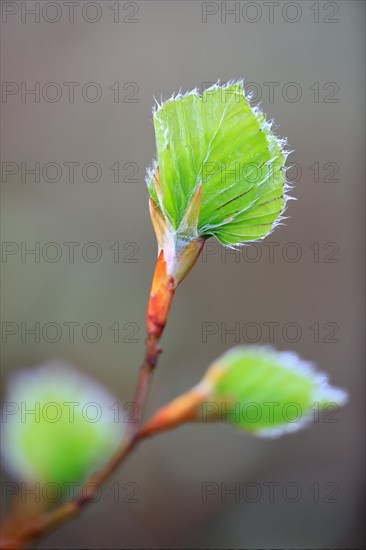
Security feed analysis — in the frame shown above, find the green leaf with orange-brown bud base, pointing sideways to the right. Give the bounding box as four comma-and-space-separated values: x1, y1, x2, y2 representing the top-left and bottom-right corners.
143, 346, 347, 437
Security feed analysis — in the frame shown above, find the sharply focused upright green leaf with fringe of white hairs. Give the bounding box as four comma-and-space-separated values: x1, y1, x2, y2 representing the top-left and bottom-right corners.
147, 82, 286, 249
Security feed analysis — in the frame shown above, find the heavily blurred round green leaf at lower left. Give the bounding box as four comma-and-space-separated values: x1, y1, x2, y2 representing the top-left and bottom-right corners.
1, 363, 123, 490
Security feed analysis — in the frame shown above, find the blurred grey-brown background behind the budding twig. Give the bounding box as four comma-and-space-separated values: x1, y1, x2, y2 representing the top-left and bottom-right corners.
1, 0, 365, 548
